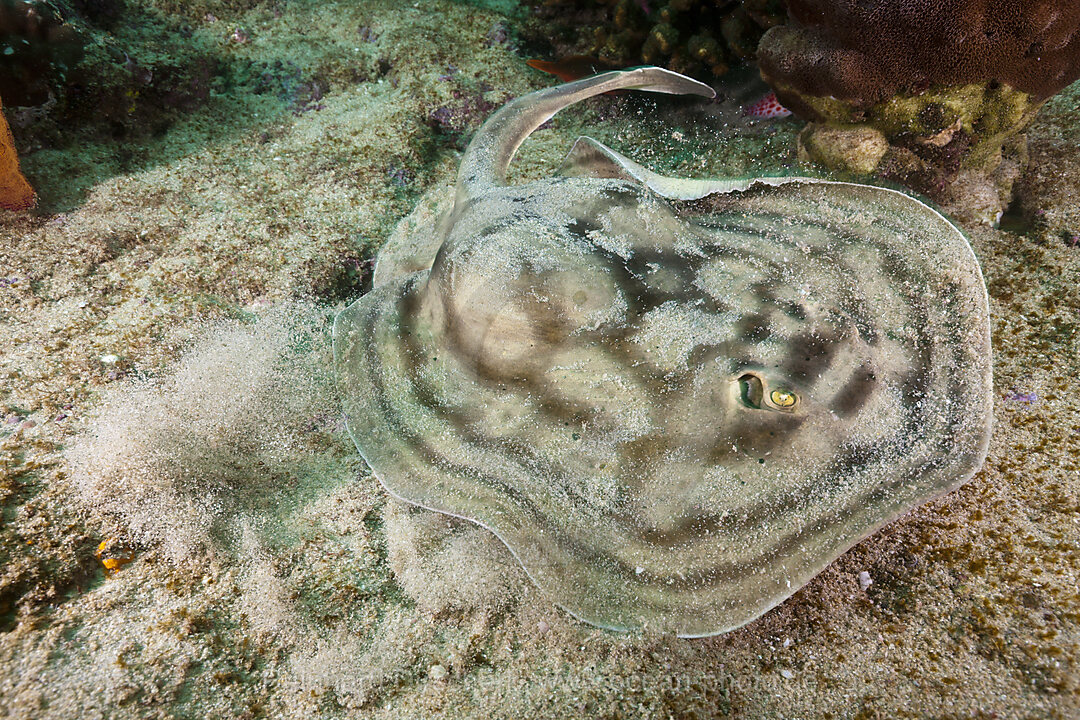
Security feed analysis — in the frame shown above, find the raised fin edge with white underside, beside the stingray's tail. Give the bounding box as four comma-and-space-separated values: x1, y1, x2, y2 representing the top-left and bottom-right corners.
558, 136, 828, 200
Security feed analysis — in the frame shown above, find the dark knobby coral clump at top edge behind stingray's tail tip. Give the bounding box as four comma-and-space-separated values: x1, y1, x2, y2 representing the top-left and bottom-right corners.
527, 0, 784, 80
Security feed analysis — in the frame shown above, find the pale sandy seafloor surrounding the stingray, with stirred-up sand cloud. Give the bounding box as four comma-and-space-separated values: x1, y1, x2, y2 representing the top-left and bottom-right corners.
0, 0, 1080, 719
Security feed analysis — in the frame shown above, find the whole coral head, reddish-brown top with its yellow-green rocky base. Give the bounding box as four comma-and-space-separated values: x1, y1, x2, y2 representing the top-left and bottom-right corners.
758, 0, 1080, 220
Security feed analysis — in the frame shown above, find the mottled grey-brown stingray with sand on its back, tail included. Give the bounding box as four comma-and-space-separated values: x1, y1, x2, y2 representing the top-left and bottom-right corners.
334, 68, 991, 637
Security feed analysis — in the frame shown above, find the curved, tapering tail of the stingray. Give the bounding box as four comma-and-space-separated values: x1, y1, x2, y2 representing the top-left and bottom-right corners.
457, 67, 716, 201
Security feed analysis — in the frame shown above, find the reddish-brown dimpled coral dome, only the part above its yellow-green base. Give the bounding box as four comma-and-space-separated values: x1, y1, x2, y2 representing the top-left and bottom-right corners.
758, 0, 1080, 120
